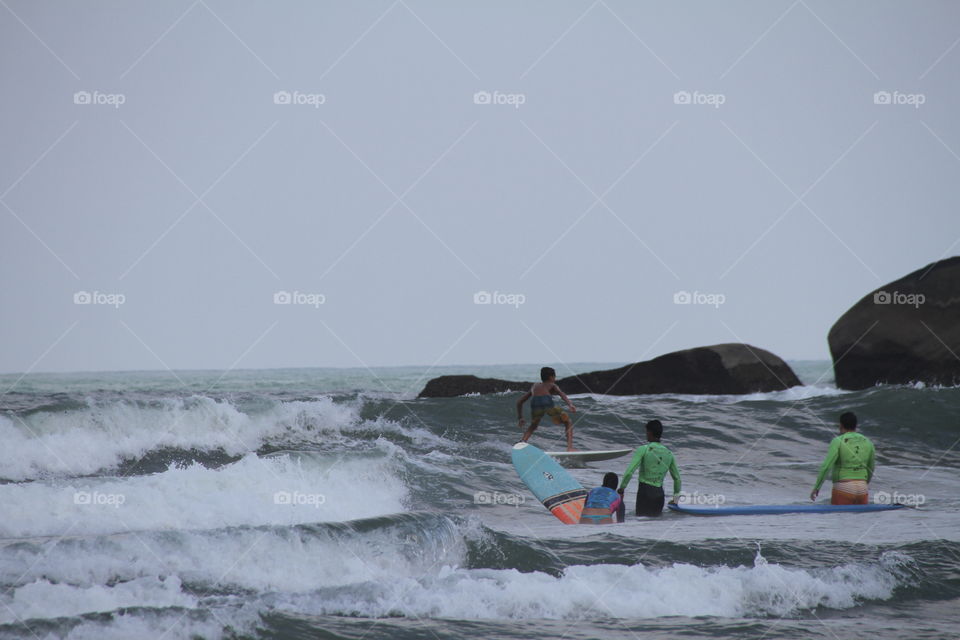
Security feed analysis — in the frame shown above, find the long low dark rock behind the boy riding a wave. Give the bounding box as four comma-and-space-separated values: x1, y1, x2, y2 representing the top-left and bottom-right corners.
420, 343, 800, 398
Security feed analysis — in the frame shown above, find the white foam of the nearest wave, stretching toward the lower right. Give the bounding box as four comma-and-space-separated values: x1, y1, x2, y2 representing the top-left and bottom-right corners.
285, 557, 898, 620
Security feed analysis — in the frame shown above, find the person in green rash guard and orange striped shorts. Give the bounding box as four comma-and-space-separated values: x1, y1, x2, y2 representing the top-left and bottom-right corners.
810, 411, 875, 504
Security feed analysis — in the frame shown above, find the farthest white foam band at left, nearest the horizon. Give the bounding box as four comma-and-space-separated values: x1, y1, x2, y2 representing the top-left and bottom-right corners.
0, 396, 442, 480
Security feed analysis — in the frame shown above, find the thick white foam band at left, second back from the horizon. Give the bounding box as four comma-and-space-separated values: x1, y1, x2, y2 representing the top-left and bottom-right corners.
0, 440, 407, 537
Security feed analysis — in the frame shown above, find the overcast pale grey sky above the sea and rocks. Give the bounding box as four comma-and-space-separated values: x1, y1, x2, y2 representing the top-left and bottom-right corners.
0, 0, 960, 372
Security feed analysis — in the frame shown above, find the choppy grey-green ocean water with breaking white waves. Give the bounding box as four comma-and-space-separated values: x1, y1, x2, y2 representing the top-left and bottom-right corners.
0, 362, 960, 640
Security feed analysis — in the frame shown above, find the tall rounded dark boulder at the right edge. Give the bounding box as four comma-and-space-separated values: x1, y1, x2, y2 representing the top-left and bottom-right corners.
827, 257, 960, 389
